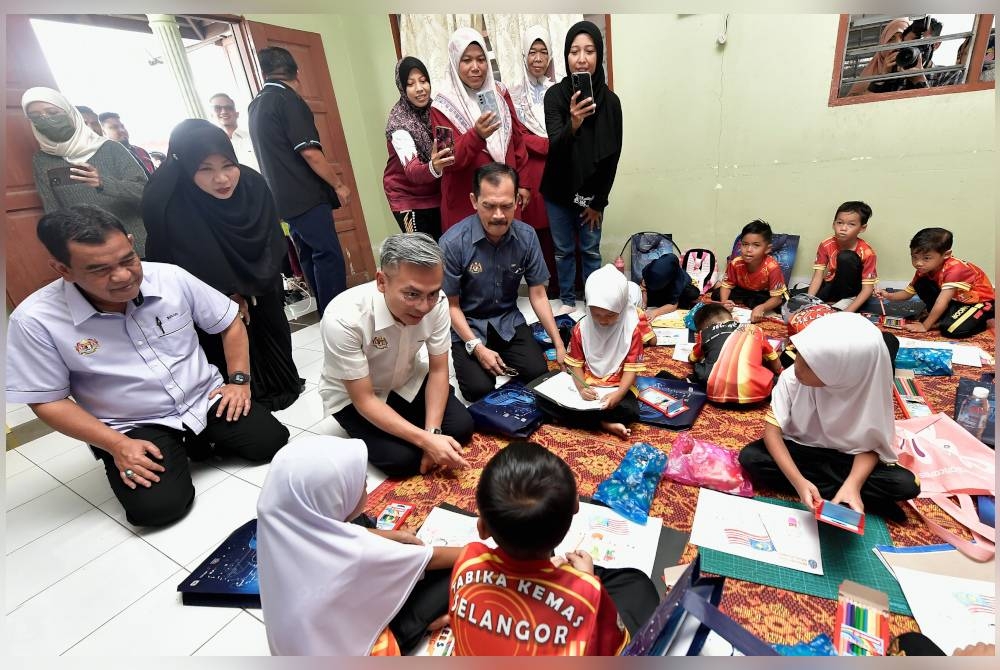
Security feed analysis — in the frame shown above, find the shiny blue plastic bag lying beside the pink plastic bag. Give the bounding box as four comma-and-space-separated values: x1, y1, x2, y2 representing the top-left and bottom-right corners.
594, 442, 667, 525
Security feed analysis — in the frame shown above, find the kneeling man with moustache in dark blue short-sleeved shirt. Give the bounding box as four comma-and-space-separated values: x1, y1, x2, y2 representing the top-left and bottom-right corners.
439, 163, 566, 402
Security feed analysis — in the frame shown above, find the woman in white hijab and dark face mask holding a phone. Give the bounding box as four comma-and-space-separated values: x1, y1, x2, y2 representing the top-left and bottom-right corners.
21, 87, 146, 257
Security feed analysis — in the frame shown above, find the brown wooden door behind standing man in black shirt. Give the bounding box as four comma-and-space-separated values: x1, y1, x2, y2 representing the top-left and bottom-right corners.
244, 21, 375, 286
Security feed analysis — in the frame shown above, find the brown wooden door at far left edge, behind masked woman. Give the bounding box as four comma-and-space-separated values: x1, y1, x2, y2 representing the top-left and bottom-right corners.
4, 14, 58, 308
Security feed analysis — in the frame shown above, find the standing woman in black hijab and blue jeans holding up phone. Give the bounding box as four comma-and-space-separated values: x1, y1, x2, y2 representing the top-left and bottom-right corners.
540, 21, 622, 314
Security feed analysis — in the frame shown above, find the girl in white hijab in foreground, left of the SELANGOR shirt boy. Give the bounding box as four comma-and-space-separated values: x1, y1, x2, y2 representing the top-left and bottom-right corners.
257, 436, 459, 656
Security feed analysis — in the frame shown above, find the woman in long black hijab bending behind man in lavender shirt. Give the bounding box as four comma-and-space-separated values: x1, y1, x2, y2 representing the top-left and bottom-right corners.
142, 119, 303, 411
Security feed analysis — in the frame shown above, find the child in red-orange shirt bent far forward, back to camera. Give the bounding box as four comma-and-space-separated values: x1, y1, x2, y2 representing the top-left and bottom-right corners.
691, 303, 782, 405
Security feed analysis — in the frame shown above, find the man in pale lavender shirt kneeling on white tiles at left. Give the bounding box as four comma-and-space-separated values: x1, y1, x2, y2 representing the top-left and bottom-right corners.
7, 205, 288, 526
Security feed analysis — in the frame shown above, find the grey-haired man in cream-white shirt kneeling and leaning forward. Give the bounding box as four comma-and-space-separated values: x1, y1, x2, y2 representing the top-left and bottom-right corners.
319, 233, 473, 478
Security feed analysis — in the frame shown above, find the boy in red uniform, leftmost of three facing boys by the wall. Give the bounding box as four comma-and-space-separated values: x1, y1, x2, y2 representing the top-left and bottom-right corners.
712, 219, 788, 323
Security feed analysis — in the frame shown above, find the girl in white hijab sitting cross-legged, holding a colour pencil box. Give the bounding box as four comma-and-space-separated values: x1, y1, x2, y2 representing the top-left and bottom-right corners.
740, 312, 920, 520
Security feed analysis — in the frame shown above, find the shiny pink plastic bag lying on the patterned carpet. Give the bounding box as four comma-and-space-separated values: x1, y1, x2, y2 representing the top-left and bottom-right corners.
663, 432, 753, 498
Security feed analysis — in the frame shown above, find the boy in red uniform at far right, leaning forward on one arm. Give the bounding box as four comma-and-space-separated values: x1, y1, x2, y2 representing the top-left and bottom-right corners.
878, 228, 996, 337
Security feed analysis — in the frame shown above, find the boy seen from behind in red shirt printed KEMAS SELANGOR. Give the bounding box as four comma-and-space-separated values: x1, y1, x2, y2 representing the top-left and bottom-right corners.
450, 444, 658, 656
